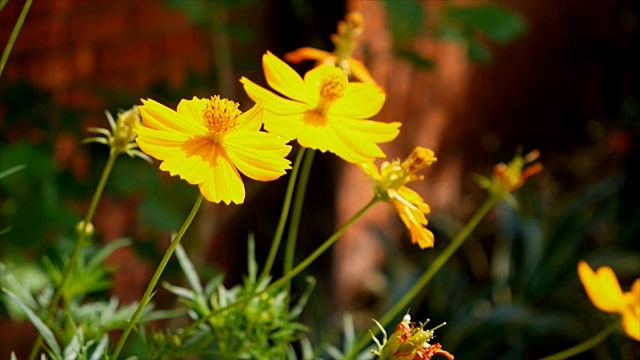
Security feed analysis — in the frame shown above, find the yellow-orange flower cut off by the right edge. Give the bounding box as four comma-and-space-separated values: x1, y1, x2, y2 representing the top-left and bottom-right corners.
578, 261, 640, 341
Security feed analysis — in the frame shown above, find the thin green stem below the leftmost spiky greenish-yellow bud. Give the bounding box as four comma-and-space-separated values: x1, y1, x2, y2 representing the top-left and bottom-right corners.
29, 150, 118, 360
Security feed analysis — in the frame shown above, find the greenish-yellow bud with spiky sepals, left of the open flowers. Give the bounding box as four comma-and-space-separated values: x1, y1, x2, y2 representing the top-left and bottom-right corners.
82, 106, 151, 162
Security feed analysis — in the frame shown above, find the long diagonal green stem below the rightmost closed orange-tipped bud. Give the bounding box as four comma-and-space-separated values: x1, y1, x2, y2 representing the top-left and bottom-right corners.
347, 195, 502, 358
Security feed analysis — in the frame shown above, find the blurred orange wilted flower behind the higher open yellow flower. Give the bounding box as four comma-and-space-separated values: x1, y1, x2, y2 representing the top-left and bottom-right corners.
284, 11, 375, 83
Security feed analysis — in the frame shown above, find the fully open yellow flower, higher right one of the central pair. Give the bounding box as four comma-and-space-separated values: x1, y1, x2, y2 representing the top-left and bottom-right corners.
240, 52, 400, 163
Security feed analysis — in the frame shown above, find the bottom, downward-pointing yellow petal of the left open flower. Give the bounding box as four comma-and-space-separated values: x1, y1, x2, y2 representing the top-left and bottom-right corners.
199, 146, 245, 205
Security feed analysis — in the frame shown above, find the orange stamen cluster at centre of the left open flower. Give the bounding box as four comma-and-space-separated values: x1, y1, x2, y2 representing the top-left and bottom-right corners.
202, 95, 242, 142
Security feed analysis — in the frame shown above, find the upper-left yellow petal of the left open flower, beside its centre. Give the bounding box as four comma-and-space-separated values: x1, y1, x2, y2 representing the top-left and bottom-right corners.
138, 100, 207, 135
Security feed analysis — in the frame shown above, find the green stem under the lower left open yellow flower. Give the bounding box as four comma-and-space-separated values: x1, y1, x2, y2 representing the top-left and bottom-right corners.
112, 194, 203, 360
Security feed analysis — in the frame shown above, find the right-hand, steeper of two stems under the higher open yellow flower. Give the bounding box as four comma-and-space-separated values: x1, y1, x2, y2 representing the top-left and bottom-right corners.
282, 149, 315, 294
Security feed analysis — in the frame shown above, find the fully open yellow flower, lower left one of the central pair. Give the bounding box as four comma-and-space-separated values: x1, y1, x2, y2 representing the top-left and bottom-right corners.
136, 96, 291, 204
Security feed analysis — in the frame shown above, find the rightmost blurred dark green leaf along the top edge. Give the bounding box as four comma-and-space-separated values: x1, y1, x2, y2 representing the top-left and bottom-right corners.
447, 4, 527, 44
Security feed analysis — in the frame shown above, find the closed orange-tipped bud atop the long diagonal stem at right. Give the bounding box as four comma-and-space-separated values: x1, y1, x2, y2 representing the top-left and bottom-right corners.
478, 150, 542, 204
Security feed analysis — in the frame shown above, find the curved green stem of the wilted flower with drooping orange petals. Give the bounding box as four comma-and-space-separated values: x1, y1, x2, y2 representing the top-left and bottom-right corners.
185, 197, 380, 333
